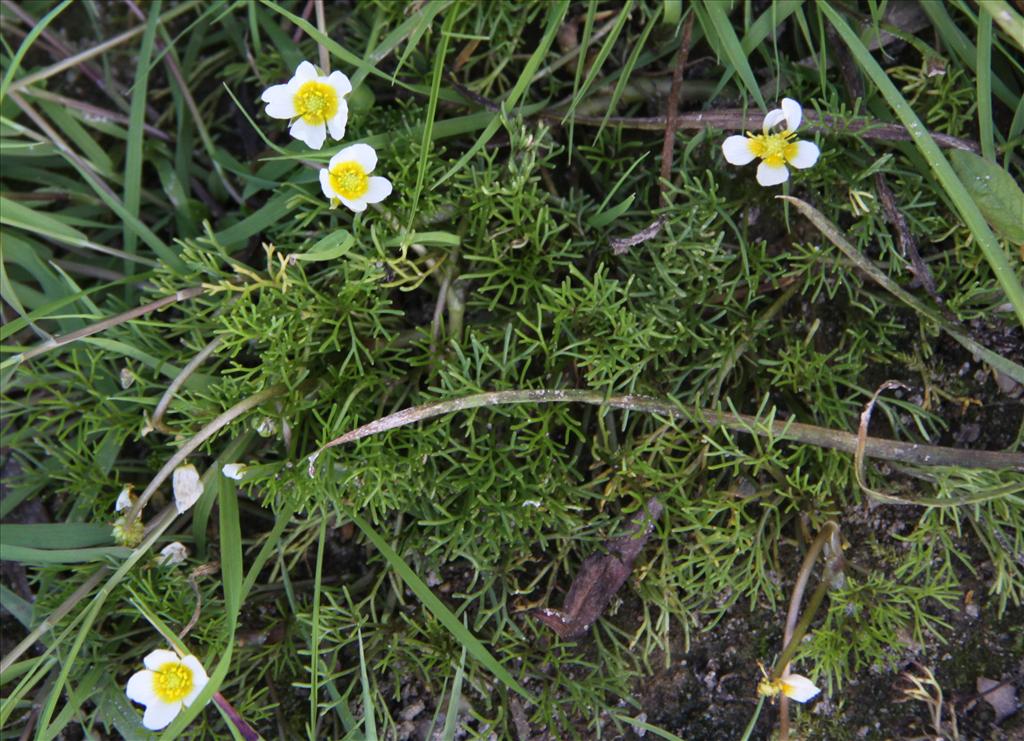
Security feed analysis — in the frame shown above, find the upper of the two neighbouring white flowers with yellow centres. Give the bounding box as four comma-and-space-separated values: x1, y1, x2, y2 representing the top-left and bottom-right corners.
260, 61, 352, 149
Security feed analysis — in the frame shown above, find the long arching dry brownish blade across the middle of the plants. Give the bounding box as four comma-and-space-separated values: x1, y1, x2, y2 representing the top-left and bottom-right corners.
308, 389, 1024, 474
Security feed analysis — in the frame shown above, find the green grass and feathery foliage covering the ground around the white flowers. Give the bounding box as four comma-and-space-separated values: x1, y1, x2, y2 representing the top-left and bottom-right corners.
0, 0, 1024, 740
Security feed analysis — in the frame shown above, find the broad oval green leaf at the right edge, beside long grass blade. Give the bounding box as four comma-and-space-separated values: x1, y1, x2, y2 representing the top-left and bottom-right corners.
949, 149, 1024, 245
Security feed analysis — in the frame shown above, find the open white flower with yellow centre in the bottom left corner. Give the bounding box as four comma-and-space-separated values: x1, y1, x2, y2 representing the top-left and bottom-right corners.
126, 649, 210, 731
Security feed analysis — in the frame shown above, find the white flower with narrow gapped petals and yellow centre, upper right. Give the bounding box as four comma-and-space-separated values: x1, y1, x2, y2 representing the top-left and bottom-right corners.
722, 98, 821, 185
